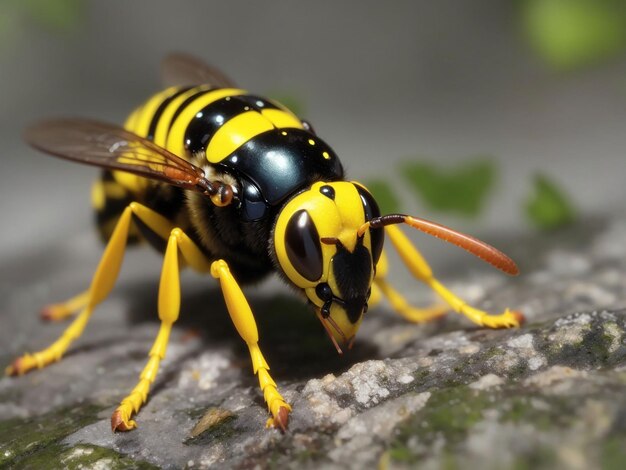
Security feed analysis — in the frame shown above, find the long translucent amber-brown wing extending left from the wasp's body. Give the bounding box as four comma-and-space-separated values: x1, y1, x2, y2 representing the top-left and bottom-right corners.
24, 119, 212, 193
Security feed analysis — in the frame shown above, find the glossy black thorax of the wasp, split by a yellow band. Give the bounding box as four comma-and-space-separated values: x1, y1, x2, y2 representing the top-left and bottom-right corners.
185, 95, 343, 221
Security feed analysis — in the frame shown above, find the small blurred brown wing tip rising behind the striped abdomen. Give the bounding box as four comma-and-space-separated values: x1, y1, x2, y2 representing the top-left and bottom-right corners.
161, 52, 236, 88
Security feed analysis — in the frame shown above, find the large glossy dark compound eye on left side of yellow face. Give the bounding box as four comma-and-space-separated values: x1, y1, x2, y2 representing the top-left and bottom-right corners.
285, 210, 322, 281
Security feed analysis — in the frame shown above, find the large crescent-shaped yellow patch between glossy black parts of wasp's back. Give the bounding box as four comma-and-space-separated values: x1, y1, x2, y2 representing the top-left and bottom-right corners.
206, 111, 274, 163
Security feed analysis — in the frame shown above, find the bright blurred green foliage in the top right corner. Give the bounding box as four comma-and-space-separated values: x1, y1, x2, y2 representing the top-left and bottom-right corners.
522, 0, 626, 70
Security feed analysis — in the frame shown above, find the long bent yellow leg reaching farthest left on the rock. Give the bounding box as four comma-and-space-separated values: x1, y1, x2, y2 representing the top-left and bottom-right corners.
5, 203, 173, 375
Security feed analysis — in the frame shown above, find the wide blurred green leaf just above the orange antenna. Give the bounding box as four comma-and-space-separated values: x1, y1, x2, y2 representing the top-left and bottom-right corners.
401, 157, 496, 217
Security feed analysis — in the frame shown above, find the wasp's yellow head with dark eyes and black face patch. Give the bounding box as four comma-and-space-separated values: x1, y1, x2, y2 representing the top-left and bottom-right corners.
273, 181, 384, 351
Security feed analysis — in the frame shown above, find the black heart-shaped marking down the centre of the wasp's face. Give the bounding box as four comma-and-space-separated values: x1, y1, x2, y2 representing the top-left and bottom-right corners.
332, 242, 372, 324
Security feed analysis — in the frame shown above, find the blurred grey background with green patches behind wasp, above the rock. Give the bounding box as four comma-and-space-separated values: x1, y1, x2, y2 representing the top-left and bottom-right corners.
0, 0, 626, 276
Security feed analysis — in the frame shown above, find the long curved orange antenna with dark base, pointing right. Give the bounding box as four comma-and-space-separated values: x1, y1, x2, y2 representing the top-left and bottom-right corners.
357, 214, 519, 276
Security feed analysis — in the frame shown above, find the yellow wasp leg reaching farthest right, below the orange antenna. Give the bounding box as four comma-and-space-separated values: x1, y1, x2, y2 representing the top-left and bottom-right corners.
381, 225, 523, 328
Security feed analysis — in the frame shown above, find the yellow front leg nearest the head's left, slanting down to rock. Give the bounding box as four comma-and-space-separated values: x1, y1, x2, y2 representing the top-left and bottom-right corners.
211, 260, 291, 432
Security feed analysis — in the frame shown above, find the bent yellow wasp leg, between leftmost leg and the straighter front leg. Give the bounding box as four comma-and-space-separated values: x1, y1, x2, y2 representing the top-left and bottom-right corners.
111, 226, 210, 431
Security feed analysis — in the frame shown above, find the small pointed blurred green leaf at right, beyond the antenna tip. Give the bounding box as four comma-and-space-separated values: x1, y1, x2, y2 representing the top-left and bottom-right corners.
526, 173, 576, 230
